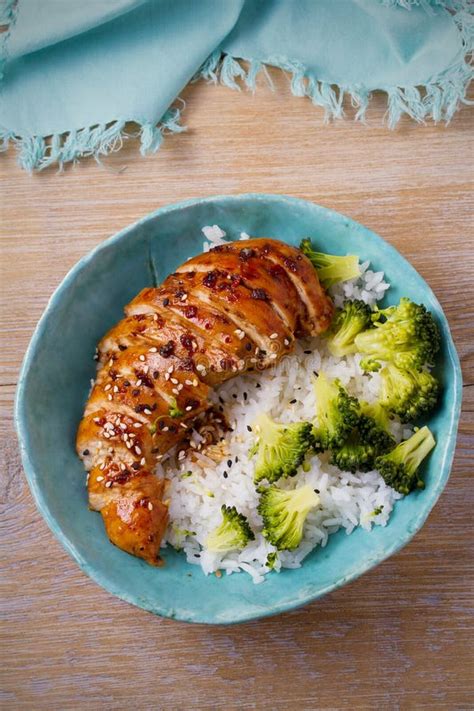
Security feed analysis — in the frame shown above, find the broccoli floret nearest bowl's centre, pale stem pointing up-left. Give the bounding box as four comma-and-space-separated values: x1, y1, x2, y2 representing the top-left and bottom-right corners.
250, 414, 314, 483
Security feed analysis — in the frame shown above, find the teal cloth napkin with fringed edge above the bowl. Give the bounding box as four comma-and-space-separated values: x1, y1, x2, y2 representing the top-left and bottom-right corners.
0, 0, 474, 170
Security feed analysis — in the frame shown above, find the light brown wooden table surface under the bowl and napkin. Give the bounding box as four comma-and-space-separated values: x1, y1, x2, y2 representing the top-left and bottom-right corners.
0, 75, 474, 710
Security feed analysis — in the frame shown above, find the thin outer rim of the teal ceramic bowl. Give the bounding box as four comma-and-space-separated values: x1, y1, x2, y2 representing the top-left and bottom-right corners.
14, 193, 462, 625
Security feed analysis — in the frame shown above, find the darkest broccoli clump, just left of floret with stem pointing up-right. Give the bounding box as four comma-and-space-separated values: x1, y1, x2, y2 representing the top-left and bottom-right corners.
331, 402, 395, 473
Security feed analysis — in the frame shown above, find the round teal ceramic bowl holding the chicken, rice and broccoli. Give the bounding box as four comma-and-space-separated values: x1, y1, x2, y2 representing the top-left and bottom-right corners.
16, 195, 461, 624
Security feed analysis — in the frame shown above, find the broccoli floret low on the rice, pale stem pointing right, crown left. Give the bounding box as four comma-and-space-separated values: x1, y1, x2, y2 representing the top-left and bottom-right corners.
258, 484, 319, 551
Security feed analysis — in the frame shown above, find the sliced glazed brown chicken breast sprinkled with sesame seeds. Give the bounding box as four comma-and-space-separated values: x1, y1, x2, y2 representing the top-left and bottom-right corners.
76, 239, 333, 565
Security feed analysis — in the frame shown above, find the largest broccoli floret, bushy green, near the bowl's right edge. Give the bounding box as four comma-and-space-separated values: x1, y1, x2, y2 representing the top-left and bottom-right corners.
355, 298, 440, 368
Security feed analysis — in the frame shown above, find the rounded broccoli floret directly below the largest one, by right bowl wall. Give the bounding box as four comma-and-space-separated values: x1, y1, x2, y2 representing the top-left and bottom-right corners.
380, 363, 439, 422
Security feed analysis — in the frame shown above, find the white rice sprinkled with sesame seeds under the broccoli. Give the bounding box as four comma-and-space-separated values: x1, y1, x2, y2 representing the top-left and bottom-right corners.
158, 225, 404, 583
